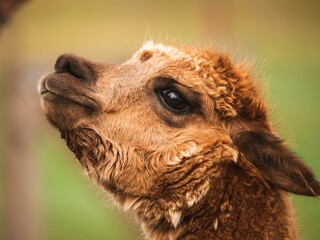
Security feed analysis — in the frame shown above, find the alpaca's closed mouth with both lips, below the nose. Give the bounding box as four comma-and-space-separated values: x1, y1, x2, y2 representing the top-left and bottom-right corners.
39, 74, 101, 111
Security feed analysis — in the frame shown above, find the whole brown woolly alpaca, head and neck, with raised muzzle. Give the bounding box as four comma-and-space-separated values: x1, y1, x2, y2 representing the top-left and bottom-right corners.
39, 41, 320, 240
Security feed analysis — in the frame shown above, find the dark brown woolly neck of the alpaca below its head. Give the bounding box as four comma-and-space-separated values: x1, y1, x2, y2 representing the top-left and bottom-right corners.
136, 162, 297, 240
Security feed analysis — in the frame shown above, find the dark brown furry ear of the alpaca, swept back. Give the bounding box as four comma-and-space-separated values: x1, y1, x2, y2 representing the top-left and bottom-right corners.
232, 130, 320, 196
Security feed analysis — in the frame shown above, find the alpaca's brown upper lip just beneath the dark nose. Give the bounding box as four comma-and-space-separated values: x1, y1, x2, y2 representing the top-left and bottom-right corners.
39, 75, 101, 110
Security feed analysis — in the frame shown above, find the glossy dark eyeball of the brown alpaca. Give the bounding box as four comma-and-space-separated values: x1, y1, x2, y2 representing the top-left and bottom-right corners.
158, 89, 190, 113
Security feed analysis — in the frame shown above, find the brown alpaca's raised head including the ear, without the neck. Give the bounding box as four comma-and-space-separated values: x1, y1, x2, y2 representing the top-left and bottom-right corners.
39, 42, 320, 208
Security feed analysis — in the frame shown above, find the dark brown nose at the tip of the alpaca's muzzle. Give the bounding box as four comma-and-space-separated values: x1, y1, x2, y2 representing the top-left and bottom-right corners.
54, 54, 96, 82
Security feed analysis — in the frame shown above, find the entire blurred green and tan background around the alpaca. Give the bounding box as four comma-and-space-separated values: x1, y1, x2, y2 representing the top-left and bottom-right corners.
0, 0, 320, 240
